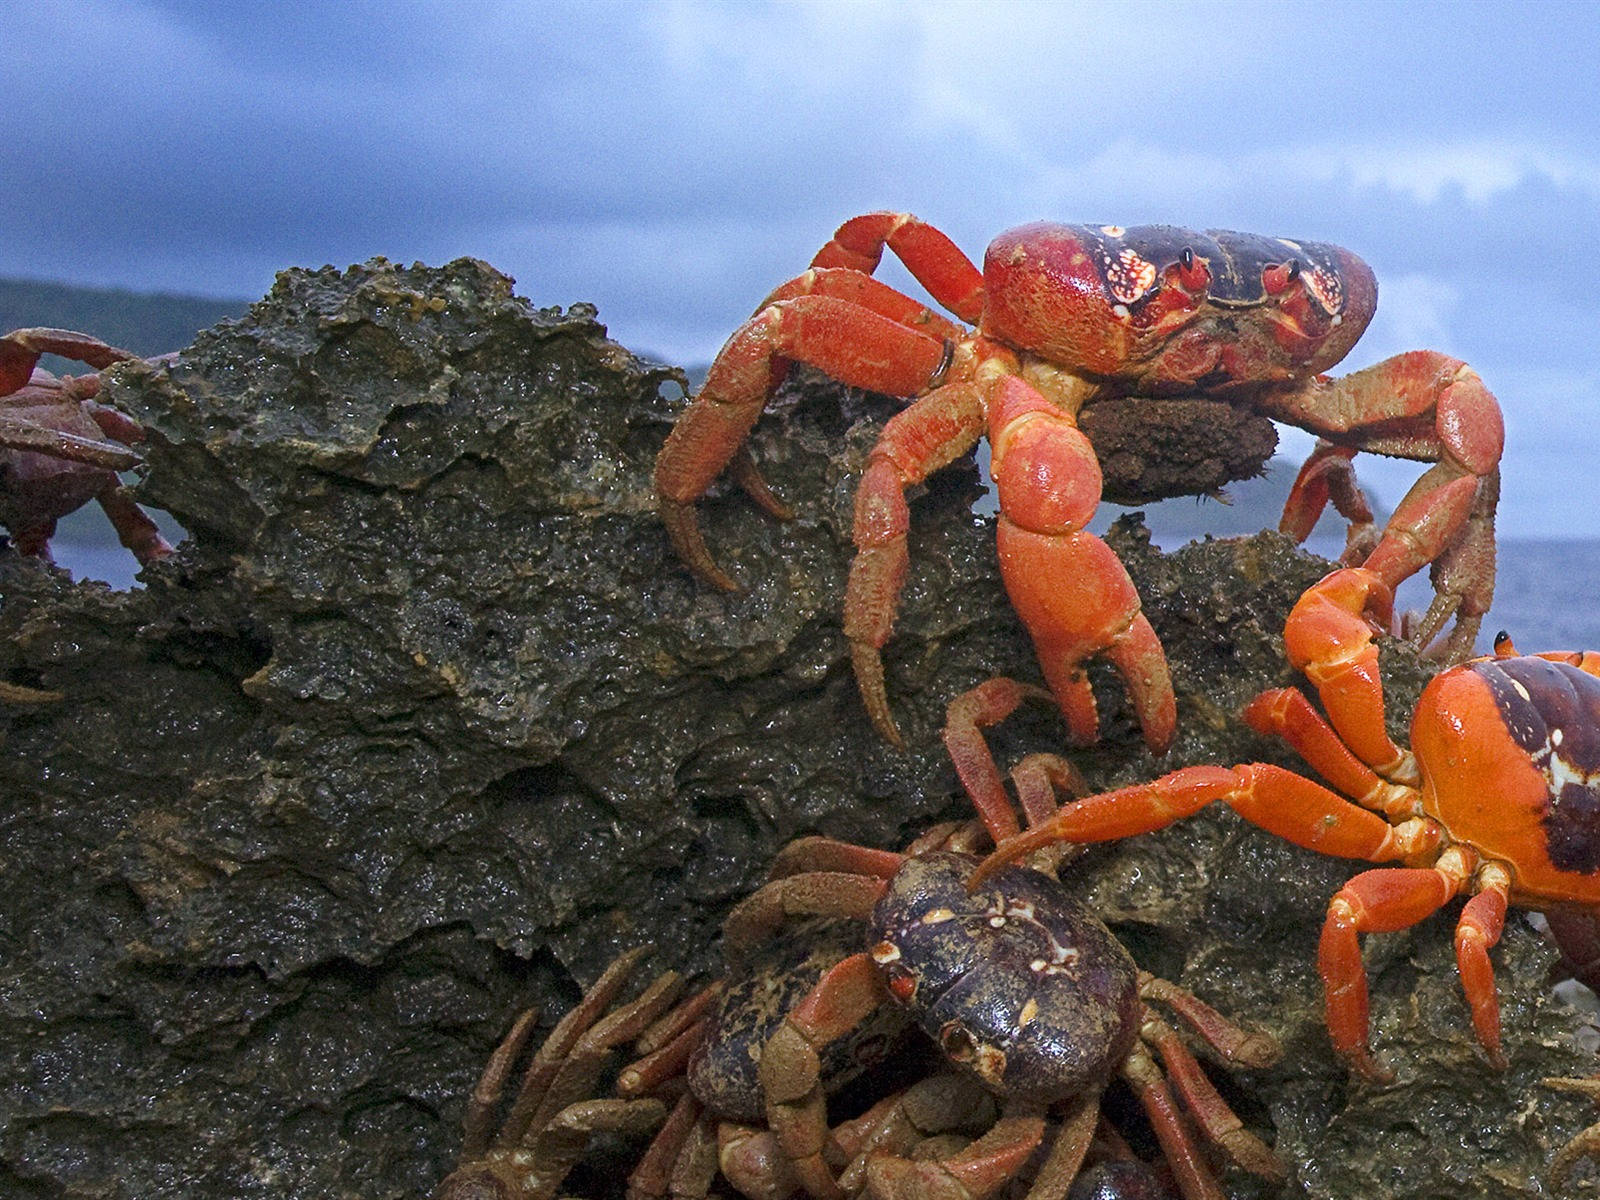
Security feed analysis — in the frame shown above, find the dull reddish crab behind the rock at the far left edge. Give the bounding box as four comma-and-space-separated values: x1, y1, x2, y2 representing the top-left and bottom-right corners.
0, 330, 173, 563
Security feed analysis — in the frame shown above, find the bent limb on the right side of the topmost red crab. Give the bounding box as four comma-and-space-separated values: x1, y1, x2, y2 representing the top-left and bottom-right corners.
1272, 350, 1506, 661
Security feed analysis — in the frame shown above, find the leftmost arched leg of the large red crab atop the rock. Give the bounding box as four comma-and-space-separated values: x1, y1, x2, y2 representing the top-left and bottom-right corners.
656, 294, 949, 592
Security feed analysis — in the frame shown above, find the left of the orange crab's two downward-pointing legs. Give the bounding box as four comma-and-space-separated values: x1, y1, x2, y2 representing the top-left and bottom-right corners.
1317, 848, 1470, 1082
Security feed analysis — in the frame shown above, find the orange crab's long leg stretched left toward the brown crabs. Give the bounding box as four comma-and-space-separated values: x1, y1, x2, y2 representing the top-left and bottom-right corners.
970, 763, 1443, 891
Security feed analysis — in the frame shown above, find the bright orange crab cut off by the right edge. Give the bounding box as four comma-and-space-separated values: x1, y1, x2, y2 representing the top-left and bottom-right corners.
973, 568, 1600, 1080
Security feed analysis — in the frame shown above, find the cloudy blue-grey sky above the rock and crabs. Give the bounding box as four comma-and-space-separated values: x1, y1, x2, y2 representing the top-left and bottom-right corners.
12, 0, 1600, 536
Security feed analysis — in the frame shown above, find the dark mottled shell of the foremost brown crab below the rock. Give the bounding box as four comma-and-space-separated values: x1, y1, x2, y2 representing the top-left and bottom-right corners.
872, 853, 1139, 1104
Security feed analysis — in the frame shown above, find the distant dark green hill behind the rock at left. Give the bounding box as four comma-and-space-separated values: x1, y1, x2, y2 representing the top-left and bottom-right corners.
0, 278, 251, 356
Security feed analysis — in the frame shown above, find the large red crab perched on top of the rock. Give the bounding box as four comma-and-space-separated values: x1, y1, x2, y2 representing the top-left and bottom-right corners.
656, 213, 1502, 752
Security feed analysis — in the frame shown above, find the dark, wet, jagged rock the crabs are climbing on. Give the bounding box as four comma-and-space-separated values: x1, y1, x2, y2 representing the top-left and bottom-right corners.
0, 261, 1594, 1200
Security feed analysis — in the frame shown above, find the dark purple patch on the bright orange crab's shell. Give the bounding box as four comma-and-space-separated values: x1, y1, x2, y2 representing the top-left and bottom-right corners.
1472, 656, 1600, 874
